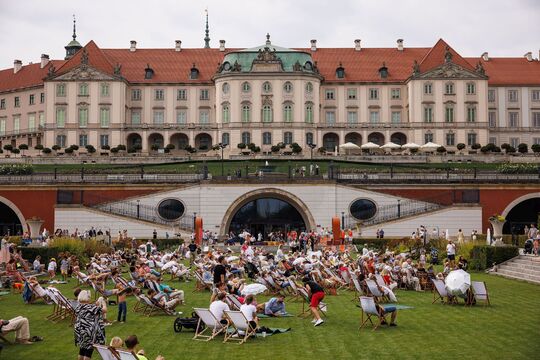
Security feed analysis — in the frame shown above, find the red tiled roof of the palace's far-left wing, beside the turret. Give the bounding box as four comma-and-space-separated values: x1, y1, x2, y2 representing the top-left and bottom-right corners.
0, 60, 65, 92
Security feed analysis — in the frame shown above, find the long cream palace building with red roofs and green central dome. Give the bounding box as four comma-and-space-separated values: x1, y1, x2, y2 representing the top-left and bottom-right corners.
0, 19, 540, 155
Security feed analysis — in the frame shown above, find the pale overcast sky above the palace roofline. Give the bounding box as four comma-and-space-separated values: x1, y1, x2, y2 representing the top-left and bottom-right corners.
0, 0, 540, 69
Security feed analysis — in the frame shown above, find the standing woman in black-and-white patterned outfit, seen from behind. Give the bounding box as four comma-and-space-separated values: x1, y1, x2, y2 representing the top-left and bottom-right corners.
73, 290, 105, 360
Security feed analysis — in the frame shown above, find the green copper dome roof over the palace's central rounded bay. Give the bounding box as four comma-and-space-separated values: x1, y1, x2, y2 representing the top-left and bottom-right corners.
218, 34, 316, 73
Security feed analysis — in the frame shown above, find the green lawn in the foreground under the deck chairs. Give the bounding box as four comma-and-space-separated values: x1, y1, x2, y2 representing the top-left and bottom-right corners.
0, 273, 540, 360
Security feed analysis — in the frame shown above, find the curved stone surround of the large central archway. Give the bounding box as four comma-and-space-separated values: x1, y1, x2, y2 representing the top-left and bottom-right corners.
219, 188, 317, 236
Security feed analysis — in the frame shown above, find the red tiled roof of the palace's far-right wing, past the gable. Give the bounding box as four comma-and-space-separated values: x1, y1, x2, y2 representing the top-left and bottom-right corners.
467, 57, 540, 86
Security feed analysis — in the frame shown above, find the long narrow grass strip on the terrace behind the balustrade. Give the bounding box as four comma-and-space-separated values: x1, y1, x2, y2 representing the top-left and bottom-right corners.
29, 160, 499, 175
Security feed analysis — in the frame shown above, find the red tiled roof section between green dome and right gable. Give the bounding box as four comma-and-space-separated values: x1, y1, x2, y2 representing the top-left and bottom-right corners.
299, 48, 429, 82
